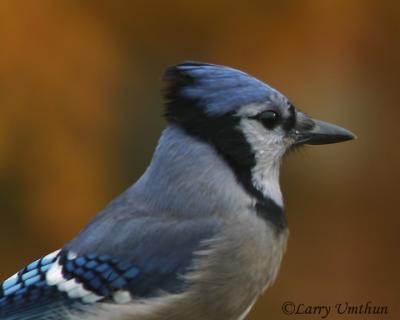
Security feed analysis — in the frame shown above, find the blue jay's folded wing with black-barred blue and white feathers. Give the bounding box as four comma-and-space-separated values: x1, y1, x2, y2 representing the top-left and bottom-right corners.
0, 215, 215, 320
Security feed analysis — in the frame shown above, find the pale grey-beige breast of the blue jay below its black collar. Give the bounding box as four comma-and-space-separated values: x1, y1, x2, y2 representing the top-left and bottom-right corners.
180, 210, 288, 319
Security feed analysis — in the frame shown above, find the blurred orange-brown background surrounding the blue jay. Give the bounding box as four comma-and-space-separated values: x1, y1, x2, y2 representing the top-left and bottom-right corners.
0, 0, 400, 320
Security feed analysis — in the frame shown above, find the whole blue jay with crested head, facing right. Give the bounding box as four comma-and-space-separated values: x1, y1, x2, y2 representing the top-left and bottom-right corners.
0, 62, 354, 320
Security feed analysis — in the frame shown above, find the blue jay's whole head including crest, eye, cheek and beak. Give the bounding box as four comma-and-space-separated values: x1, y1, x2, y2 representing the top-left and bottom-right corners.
164, 62, 355, 202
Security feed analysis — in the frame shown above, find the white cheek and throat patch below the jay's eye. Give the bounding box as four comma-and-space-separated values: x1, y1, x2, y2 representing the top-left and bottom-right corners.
239, 119, 286, 206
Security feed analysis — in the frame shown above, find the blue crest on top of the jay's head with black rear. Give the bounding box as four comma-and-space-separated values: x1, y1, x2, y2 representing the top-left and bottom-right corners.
164, 62, 277, 120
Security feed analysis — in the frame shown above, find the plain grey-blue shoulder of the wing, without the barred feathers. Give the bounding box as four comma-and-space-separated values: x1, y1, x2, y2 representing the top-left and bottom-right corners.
66, 209, 217, 298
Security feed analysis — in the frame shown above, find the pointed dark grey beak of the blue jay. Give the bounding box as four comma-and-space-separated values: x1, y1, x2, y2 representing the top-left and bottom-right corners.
295, 112, 356, 145
